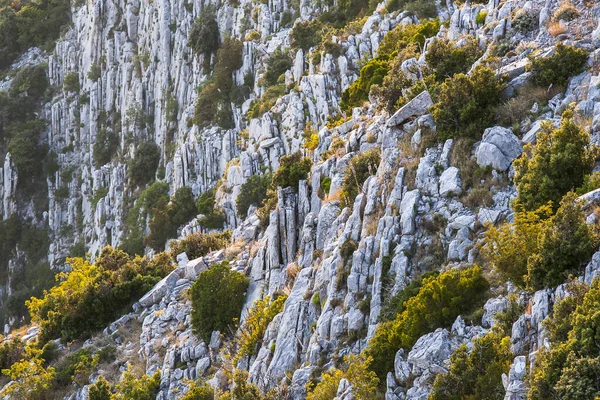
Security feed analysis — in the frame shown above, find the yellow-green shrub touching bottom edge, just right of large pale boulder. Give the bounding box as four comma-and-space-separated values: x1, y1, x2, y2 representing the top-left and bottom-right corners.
429, 330, 514, 400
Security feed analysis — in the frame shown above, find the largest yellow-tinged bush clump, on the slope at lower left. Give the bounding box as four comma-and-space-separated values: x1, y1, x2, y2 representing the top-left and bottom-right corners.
26, 247, 173, 342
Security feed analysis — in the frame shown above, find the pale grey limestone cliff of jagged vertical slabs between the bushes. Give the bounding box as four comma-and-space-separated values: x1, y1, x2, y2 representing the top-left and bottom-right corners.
0, 0, 600, 399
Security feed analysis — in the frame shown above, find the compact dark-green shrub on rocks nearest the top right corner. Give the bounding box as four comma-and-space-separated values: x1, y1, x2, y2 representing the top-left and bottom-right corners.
530, 43, 589, 86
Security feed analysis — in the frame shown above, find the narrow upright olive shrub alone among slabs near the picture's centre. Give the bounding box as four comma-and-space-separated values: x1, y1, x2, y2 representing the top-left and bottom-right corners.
340, 148, 381, 207
